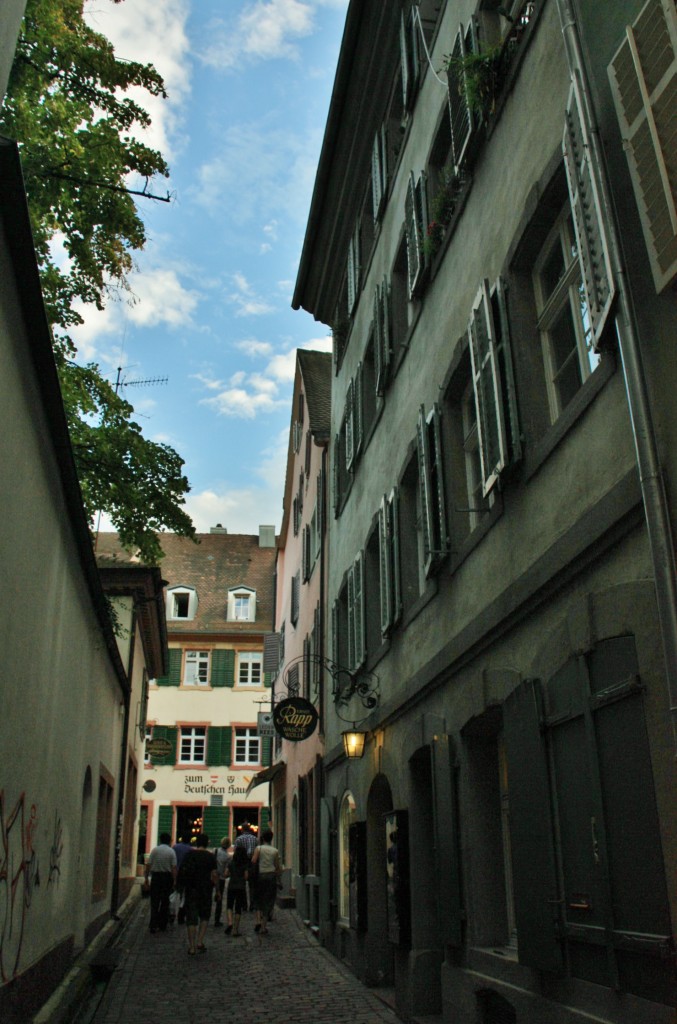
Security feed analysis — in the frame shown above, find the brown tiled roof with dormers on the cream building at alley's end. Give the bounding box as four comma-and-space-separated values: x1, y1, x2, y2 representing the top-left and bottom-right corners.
96, 534, 276, 640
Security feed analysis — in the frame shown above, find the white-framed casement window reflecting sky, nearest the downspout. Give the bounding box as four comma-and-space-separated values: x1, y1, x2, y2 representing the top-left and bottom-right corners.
534, 203, 600, 423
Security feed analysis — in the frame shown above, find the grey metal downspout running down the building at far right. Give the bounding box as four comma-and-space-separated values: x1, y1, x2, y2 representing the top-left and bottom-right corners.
557, 0, 677, 756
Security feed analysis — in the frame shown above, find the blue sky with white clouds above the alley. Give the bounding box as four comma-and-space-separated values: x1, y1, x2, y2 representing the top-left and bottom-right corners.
74, 0, 347, 534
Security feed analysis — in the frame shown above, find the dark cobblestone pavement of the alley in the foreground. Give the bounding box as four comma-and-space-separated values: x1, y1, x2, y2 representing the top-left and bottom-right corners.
87, 900, 398, 1024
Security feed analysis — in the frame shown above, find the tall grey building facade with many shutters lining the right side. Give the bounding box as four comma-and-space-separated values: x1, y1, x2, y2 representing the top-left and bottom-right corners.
294, 0, 677, 1024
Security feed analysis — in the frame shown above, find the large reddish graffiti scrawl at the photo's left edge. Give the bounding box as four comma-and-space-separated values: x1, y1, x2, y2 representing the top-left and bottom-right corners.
0, 790, 40, 984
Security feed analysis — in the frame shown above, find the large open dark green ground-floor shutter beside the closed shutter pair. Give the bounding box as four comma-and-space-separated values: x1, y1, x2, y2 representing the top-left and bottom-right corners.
503, 679, 563, 973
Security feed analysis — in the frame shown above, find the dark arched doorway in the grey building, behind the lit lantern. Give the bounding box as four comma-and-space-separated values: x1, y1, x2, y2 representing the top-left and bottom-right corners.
365, 775, 394, 986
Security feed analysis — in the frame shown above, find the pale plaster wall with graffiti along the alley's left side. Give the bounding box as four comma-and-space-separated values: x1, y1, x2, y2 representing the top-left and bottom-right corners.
0, 218, 123, 982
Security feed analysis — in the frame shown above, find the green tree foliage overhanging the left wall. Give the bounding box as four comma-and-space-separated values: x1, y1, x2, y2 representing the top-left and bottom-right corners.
0, 0, 194, 560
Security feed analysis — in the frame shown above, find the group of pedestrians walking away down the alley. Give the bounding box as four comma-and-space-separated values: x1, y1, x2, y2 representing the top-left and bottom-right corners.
145, 823, 282, 955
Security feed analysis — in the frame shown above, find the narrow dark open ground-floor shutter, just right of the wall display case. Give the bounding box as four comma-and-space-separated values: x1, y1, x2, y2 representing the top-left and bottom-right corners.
430, 735, 463, 946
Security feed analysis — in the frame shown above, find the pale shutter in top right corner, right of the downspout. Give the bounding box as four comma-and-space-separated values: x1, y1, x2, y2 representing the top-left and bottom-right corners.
608, 0, 677, 292
